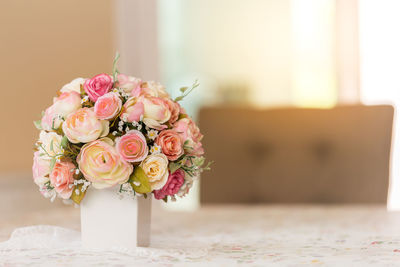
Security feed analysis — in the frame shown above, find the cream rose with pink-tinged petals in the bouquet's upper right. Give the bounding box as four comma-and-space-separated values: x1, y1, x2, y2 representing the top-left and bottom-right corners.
141, 97, 171, 130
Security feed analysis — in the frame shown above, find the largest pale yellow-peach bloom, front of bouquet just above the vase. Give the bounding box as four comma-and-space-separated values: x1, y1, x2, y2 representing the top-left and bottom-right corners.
76, 138, 133, 189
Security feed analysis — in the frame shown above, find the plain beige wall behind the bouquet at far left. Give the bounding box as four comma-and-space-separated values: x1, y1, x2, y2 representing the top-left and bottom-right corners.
0, 0, 114, 172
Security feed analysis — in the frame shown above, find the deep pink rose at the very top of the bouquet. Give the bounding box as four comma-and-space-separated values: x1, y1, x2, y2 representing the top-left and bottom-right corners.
83, 73, 113, 102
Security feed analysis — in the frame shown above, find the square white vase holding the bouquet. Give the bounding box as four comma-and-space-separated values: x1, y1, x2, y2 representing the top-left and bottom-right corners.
80, 185, 151, 249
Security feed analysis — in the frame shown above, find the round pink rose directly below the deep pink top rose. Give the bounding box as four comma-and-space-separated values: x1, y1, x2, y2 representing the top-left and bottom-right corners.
94, 92, 122, 120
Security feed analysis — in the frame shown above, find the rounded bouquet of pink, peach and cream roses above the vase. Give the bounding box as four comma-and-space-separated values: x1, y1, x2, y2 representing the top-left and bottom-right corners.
32, 54, 210, 204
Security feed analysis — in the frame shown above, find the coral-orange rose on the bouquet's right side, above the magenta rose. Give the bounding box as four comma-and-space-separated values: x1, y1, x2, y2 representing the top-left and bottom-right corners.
155, 130, 183, 161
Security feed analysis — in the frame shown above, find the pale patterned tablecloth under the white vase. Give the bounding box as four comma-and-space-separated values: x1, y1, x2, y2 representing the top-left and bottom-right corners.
0, 206, 400, 266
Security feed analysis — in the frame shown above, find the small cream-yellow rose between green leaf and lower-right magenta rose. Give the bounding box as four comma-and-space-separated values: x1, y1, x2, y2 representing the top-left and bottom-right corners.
140, 153, 168, 190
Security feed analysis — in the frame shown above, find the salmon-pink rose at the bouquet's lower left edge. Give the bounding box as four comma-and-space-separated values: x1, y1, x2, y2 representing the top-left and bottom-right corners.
50, 161, 76, 199
